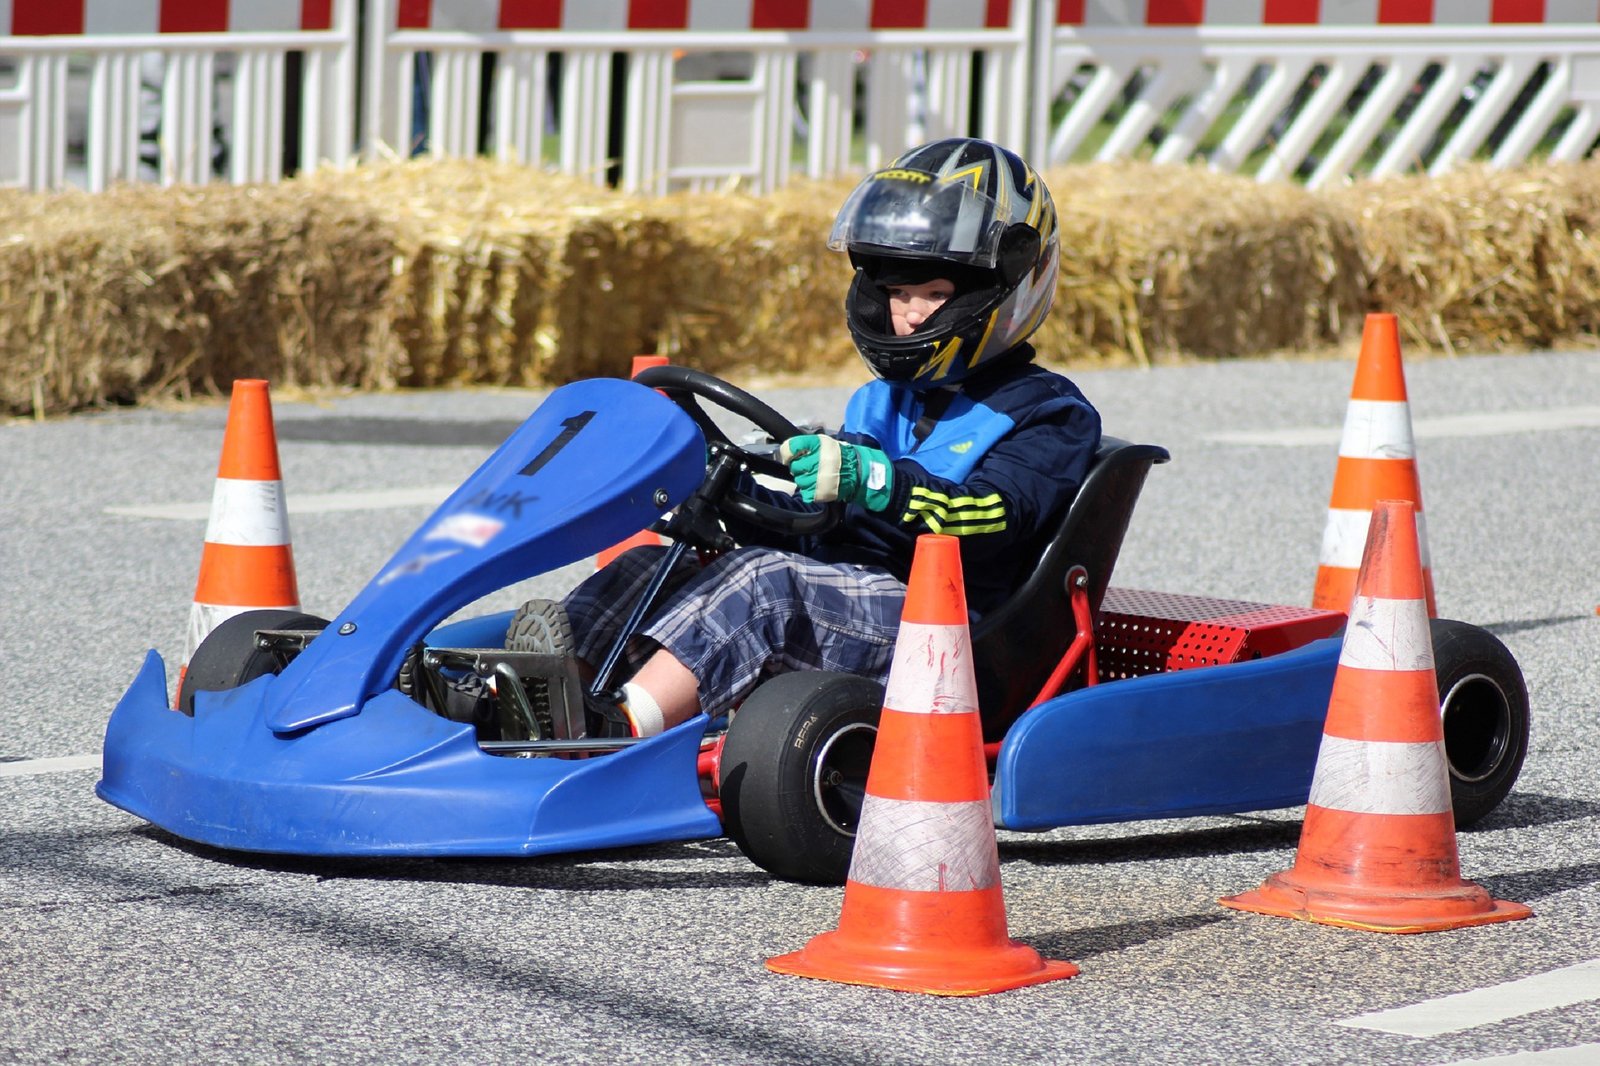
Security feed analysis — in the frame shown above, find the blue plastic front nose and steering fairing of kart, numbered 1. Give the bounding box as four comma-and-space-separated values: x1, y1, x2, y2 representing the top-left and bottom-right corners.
96, 379, 720, 855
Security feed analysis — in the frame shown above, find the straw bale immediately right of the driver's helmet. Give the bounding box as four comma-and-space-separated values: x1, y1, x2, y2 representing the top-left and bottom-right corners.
1040, 163, 1366, 362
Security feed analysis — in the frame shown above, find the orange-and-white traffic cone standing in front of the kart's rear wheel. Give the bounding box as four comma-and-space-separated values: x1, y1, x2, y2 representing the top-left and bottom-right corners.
1221, 499, 1531, 933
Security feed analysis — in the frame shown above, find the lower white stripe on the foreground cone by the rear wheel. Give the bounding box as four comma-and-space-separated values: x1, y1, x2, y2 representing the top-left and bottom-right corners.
1307, 733, 1451, 815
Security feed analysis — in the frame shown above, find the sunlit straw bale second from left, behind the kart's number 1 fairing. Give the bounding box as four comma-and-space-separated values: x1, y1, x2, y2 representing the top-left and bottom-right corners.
293, 160, 646, 386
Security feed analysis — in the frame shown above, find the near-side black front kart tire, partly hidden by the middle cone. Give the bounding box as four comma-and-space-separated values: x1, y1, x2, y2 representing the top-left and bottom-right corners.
718, 671, 883, 885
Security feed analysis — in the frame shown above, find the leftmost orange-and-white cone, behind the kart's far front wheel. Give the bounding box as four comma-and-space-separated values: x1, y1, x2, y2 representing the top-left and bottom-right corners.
179, 381, 299, 688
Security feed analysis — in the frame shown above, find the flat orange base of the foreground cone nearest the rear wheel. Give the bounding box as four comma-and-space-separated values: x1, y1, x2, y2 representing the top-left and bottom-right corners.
1218, 871, 1533, 933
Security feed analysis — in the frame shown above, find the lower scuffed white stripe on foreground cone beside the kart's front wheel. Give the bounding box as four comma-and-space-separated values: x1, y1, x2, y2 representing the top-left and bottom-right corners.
850, 792, 1000, 892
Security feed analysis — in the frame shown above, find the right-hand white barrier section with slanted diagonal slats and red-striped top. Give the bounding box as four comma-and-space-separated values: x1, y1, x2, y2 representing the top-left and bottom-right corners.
1030, 0, 1600, 187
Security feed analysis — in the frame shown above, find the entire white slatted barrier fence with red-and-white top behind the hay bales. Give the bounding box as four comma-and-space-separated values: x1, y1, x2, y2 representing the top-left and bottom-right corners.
0, 0, 1600, 192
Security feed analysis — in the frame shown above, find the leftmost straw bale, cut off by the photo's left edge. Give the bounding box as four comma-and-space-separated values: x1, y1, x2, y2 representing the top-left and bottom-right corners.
0, 176, 394, 411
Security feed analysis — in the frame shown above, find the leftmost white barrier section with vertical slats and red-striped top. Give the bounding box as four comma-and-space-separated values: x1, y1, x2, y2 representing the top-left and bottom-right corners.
0, 0, 358, 190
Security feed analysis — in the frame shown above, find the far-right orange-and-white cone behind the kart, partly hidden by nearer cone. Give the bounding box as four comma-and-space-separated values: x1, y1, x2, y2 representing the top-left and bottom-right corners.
1312, 314, 1438, 618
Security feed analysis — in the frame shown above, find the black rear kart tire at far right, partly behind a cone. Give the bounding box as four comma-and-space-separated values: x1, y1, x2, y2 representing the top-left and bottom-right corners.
1430, 618, 1530, 829
